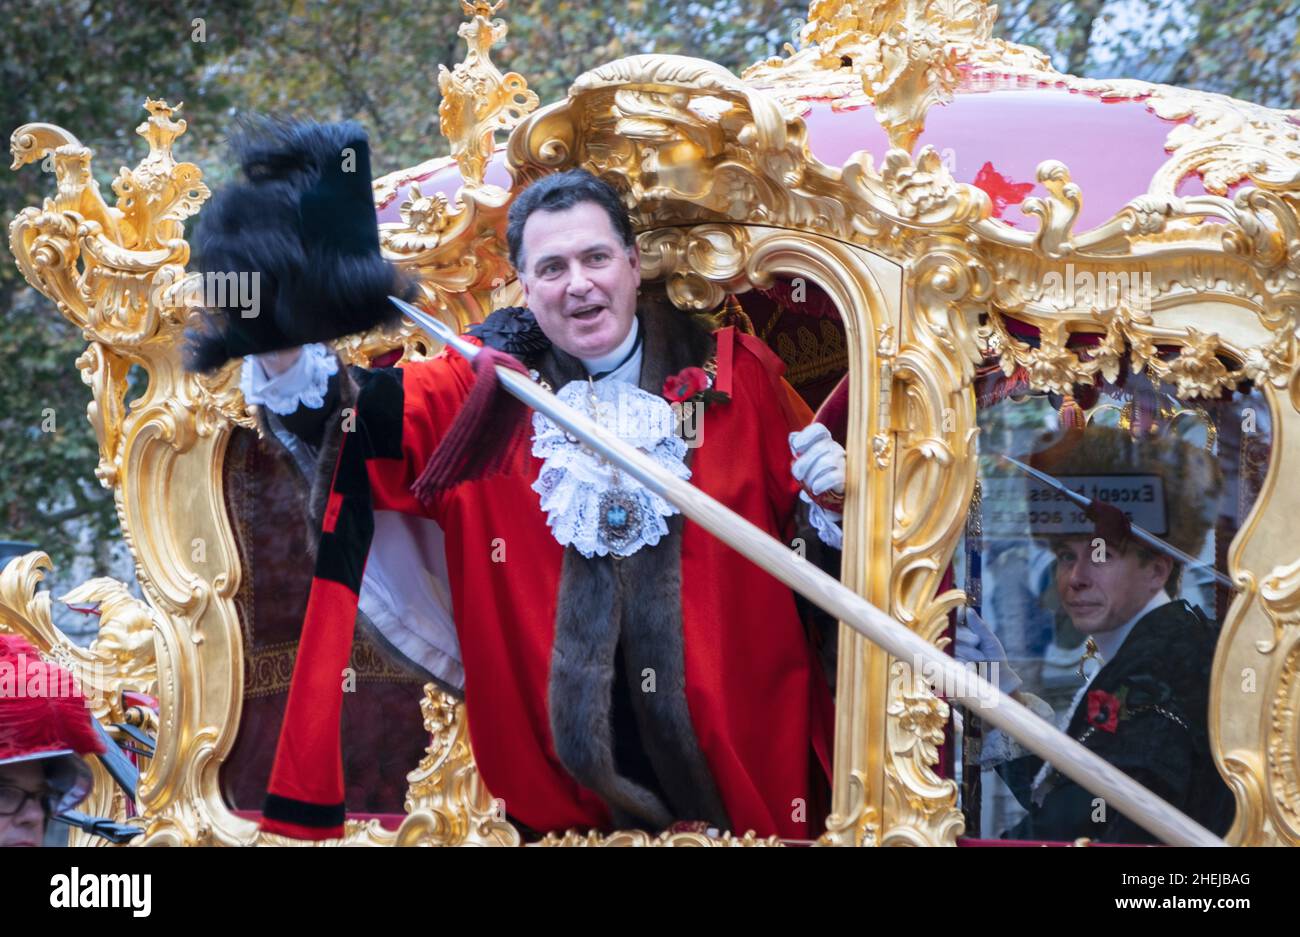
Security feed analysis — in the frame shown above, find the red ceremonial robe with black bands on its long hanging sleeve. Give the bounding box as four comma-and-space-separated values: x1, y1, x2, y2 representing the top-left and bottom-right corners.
263, 329, 833, 838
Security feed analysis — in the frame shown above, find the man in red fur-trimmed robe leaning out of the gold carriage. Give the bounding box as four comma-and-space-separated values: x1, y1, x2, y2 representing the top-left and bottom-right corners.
188, 126, 844, 838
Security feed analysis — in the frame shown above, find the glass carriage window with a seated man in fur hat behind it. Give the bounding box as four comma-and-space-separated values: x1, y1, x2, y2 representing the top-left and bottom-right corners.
950, 366, 1270, 842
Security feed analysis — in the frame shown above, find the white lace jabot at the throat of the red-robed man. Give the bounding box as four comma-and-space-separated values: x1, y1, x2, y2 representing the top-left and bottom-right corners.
533, 381, 690, 558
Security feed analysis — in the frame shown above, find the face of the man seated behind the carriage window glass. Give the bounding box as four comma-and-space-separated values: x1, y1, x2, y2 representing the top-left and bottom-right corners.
1056, 537, 1171, 634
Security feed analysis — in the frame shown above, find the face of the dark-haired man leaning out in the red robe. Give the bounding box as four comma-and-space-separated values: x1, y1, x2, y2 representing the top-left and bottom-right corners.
519, 201, 641, 357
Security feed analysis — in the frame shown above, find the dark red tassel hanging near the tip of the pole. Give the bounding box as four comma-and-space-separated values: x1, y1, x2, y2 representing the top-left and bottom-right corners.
411, 346, 528, 503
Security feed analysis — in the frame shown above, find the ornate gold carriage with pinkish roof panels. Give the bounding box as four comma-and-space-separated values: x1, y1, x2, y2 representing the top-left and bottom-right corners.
0, 0, 1300, 845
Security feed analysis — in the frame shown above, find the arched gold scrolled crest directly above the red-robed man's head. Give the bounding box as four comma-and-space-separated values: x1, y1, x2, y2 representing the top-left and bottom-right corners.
507, 55, 848, 231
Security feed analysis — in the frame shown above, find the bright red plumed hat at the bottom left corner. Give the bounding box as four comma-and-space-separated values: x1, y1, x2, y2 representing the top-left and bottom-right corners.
0, 634, 104, 812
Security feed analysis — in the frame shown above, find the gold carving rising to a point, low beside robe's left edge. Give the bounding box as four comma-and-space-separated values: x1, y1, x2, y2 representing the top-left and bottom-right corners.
395, 684, 521, 846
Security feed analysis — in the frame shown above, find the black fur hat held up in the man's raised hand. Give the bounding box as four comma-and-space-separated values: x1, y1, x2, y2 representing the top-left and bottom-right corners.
185, 118, 413, 372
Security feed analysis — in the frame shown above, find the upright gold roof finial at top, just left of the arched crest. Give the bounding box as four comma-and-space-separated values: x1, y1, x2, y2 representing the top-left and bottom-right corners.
438, 0, 538, 186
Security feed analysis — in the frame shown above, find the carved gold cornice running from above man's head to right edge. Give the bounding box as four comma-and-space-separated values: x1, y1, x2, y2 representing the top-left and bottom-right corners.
510, 40, 1300, 400
